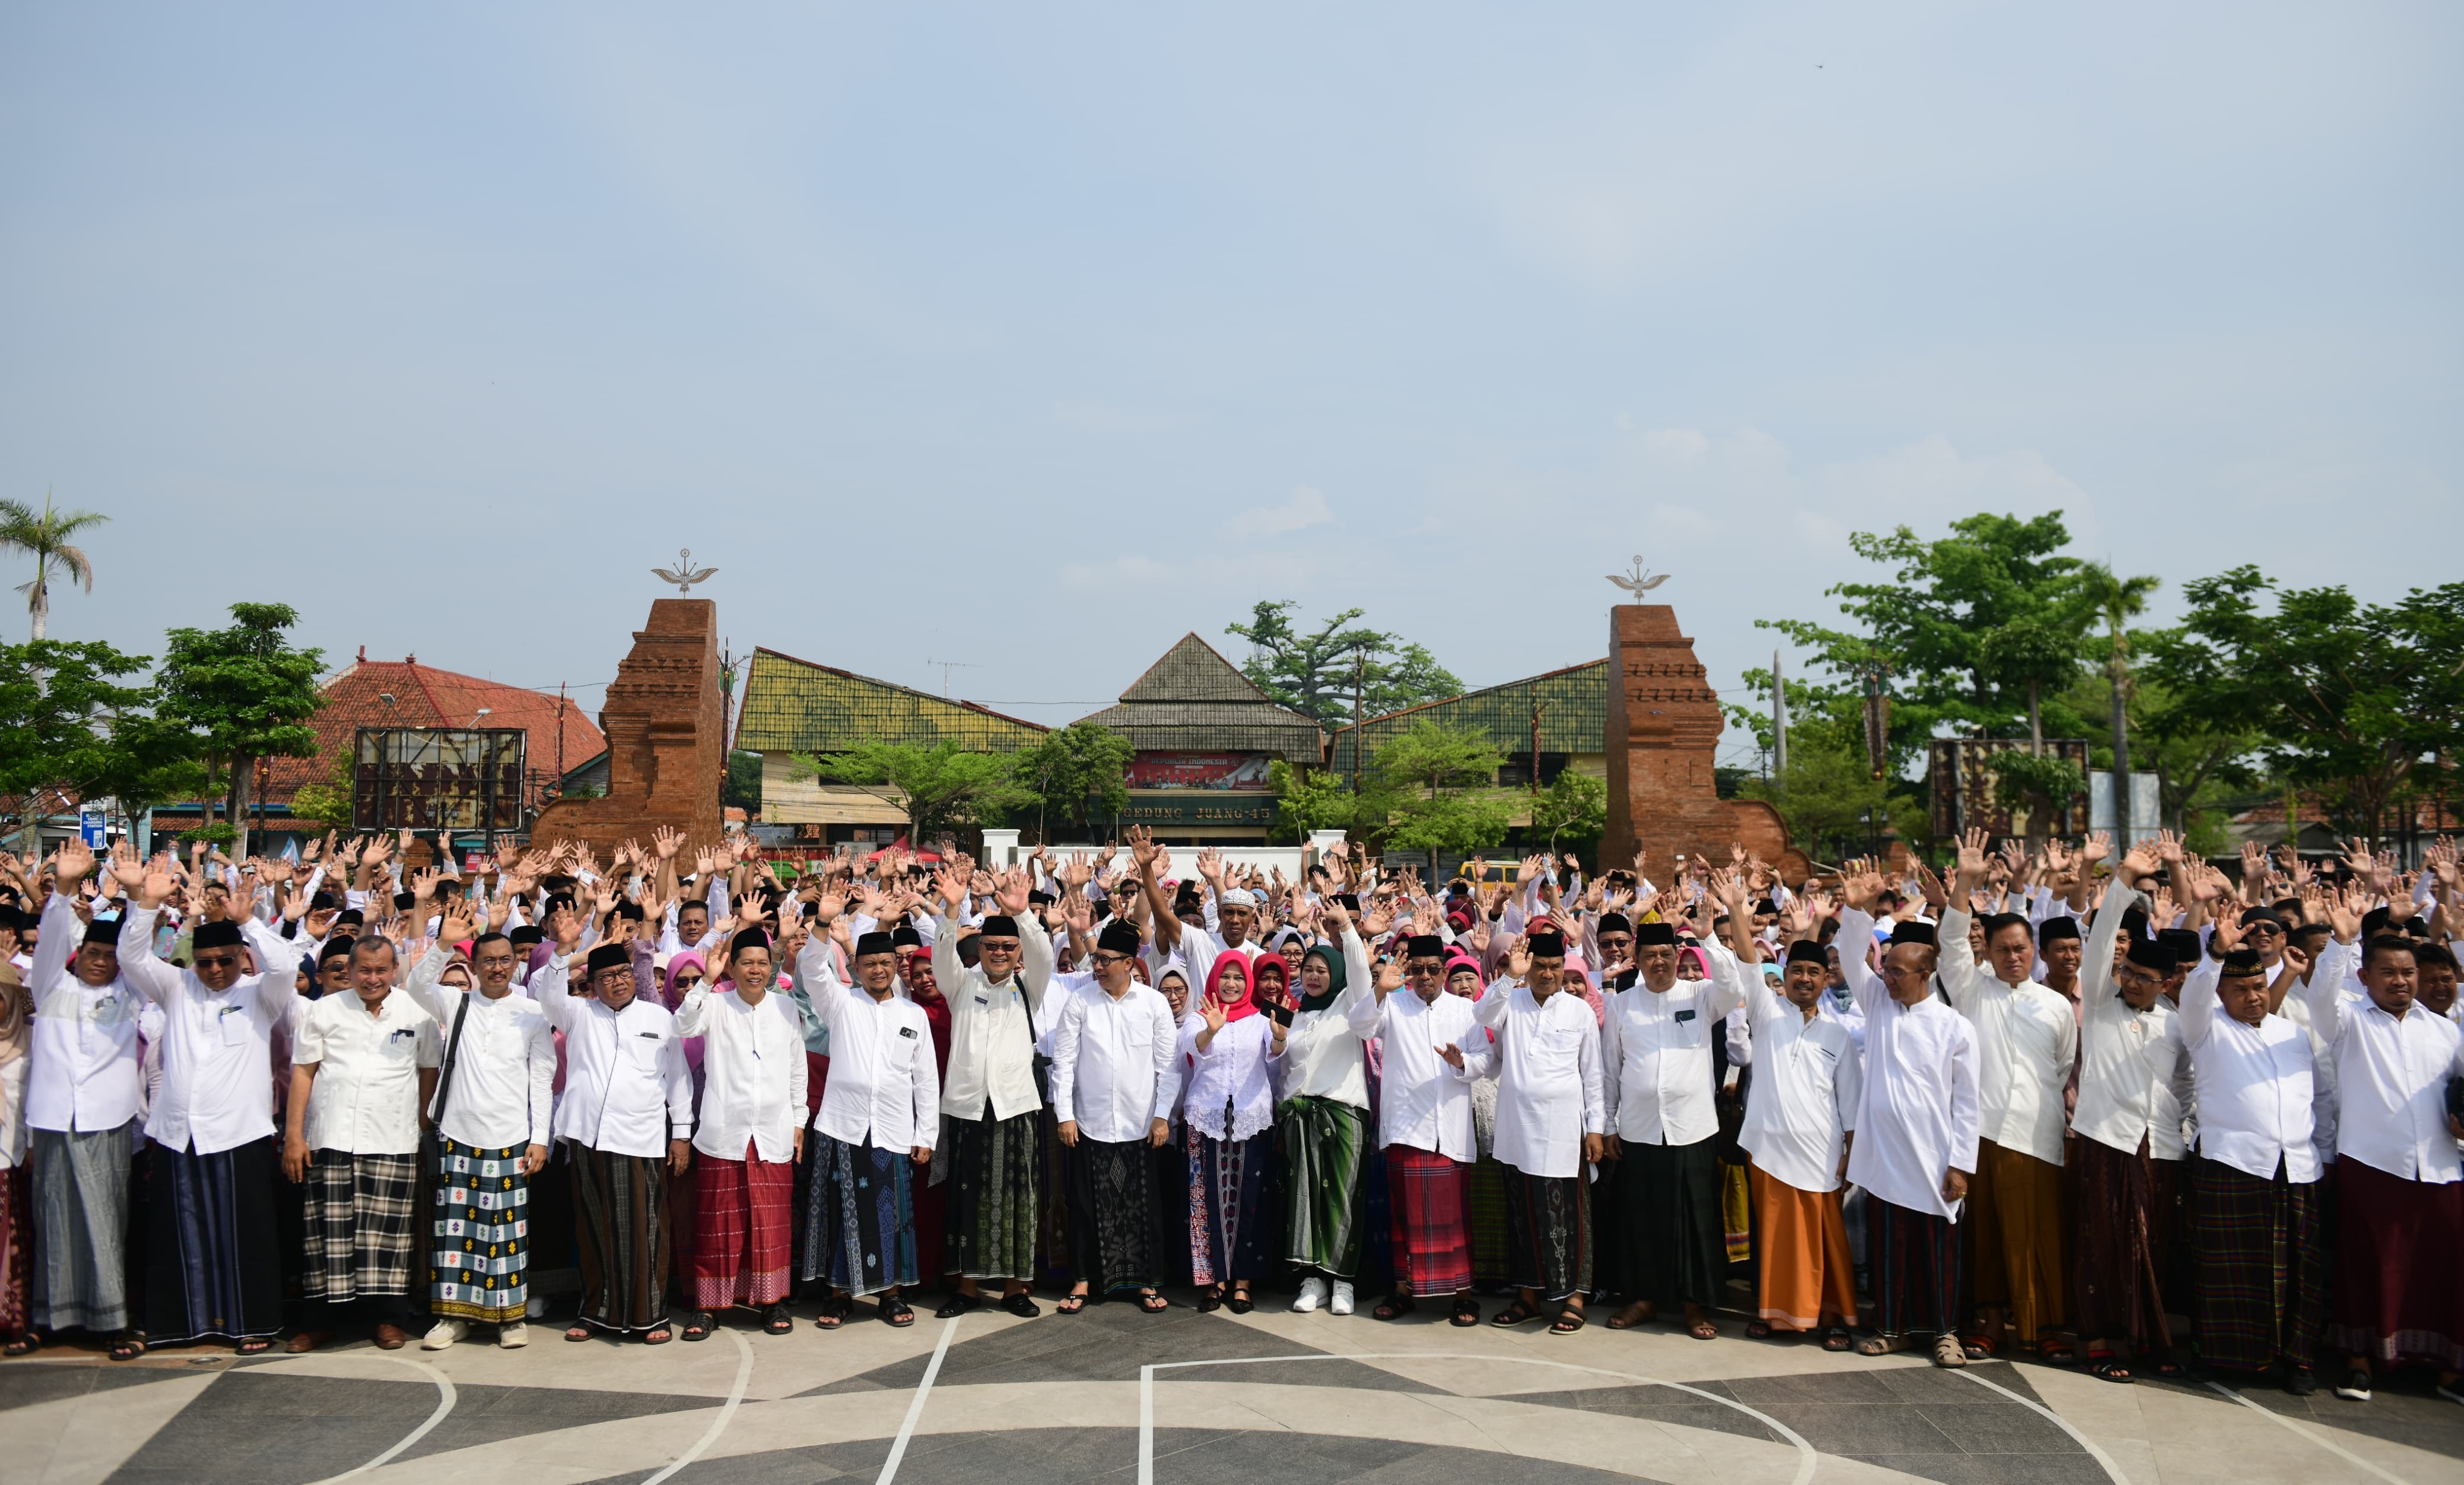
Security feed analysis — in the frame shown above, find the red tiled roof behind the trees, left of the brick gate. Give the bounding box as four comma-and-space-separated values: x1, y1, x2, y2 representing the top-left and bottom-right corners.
266, 660, 609, 803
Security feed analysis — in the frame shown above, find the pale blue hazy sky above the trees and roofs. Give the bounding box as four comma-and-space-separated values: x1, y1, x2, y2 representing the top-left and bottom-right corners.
0, 5, 2464, 768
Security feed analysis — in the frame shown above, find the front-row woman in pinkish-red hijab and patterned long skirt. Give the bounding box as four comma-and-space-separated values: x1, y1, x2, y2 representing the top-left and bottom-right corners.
1180, 953, 1284, 1315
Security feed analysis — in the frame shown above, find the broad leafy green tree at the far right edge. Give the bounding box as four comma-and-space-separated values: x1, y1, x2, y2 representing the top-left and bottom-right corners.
2144, 567, 2464, 835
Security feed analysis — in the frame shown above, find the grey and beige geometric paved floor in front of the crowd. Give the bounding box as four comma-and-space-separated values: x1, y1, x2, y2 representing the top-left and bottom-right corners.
0, 1305, 2464, 1485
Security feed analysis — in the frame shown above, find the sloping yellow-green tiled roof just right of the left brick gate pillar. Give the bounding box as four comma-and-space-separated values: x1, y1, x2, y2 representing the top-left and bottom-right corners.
737, 648, 1050, 754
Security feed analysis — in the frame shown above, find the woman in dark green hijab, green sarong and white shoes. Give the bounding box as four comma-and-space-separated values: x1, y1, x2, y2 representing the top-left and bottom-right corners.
1254, 935, 1370, 1315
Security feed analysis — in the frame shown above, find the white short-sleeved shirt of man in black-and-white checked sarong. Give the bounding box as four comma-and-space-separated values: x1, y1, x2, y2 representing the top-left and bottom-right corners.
291, 990, 443, 1155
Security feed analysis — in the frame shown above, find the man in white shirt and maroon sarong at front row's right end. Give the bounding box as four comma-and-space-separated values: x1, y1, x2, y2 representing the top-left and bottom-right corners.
2287, 902, 2464, 1401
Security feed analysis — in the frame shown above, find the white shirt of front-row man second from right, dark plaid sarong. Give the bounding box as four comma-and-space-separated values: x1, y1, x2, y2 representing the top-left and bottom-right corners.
2181, 958, 2318, 1184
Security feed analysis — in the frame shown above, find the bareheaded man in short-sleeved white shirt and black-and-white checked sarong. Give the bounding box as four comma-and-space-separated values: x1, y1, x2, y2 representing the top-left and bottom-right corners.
283, 936, 443, 1352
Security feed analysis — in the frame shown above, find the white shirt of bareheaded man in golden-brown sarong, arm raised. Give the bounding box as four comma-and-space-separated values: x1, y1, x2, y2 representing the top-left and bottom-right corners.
1939, 909, 2080, 1165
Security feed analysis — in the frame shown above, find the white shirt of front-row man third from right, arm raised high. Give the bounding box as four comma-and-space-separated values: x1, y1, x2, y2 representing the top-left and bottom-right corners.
2070, 882, 2190, 1160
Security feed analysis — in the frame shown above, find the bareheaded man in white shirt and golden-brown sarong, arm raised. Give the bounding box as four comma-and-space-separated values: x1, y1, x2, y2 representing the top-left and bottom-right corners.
1927, 830, 2080, 1362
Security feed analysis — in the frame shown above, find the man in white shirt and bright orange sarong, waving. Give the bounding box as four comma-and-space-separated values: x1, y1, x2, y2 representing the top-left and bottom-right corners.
1725, 909, 1865, 1352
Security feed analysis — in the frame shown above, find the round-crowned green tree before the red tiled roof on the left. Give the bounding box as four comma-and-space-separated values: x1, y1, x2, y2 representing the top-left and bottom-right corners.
158, 603, 325, 855
